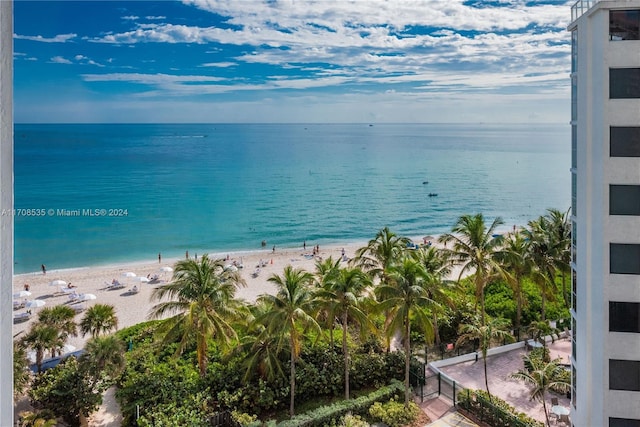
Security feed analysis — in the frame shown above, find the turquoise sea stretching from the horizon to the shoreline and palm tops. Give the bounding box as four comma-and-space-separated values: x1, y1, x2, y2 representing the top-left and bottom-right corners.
15, 124, 571, 273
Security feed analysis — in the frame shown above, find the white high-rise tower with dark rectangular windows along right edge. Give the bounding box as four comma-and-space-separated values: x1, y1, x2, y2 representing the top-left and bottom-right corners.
569, 0, 640, 427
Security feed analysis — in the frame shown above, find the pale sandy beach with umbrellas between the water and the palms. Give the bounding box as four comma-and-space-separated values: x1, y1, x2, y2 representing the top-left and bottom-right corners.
13, 239, 408, 349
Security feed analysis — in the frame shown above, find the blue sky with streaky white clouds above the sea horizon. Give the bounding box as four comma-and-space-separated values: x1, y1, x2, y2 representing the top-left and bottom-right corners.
14, 0, 574, 123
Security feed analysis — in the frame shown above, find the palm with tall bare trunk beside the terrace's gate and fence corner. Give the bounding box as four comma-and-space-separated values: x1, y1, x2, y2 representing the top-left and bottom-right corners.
375, 257, 438, 406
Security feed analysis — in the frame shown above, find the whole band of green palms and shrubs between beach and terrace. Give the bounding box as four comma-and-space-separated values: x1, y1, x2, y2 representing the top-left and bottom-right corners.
14, 210, 570, 426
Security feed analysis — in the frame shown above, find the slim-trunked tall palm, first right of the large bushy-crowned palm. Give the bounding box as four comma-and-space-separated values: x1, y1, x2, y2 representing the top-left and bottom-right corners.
258, 266, 321, 417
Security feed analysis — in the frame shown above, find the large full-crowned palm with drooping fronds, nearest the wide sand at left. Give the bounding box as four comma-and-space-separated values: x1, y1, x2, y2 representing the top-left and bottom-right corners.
149, 254, 245, 376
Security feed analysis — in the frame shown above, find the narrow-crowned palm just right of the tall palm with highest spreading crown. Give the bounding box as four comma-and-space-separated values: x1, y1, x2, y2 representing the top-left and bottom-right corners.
500, 231, 532, 335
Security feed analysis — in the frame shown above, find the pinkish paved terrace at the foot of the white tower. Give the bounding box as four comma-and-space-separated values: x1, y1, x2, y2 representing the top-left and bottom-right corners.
432, 338, 571, 422
